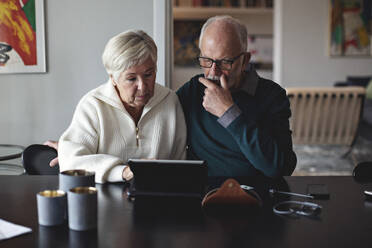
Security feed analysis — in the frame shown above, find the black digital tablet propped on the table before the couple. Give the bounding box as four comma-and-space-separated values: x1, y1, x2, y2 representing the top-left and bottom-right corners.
128, 159, 208, 198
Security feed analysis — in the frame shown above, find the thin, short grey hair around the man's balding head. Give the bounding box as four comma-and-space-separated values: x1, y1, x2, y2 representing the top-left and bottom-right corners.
199, 15, 248, 51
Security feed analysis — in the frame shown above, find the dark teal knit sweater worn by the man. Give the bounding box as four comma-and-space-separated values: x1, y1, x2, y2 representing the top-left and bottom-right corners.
177, 72, 296, 177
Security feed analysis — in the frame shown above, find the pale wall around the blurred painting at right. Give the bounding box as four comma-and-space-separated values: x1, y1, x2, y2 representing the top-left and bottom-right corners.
274, 0, 372, 87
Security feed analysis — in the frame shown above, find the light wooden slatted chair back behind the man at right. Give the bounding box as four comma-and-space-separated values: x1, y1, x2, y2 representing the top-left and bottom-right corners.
286, 87, 365, 145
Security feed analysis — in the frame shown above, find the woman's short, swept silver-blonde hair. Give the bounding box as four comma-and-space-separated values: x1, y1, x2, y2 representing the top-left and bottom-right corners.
102, 30, 157, 80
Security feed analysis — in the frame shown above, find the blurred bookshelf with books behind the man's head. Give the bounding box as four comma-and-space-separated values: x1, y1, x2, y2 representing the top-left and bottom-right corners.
172, 0, 274, 90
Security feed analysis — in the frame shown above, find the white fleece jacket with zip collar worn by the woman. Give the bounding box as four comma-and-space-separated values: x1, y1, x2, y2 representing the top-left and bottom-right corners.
58, 80, 186, 183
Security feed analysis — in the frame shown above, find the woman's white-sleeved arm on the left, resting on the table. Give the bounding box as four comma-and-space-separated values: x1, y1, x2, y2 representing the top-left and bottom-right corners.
58, 99, 126, 183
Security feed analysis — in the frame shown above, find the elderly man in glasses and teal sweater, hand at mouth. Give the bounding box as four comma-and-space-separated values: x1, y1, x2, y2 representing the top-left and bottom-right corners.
177, 16, 297, 177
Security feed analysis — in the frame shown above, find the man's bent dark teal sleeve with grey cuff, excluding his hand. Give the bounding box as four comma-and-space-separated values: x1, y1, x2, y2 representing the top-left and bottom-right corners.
219, 90, 297, 177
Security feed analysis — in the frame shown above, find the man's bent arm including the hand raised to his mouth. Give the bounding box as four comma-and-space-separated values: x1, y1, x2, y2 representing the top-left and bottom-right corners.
199, 76, 297, 177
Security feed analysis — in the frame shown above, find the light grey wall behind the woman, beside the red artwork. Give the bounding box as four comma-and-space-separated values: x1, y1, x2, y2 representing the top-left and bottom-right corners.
0, 0, 153, 145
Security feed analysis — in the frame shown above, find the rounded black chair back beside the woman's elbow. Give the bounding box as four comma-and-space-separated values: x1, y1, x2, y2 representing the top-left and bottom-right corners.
22, 144, 59, 175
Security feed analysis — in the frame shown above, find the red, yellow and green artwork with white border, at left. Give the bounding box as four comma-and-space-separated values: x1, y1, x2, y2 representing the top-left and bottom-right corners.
0, 0, 46, 73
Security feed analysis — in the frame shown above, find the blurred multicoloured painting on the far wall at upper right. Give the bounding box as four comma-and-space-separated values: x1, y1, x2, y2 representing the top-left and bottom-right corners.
329, 0, 372, 56
